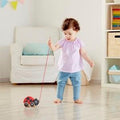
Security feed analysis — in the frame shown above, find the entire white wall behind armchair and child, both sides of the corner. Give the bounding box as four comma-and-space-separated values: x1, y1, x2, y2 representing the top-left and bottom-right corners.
0, 0, 102, 80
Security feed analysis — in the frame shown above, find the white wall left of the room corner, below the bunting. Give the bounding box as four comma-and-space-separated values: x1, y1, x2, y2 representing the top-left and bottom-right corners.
0, 0, 35, 80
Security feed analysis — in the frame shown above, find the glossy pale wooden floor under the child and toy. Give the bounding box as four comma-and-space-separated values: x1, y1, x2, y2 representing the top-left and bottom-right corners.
0, 83, 120, 120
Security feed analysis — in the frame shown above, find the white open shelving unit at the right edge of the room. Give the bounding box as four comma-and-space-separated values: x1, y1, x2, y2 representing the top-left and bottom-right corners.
101, 0, 120, 88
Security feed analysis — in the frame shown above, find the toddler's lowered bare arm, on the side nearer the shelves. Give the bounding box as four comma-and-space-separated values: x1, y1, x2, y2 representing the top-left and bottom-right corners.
80, 48, 94, 67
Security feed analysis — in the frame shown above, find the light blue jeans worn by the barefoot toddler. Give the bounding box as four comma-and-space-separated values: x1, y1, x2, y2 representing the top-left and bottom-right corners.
57, 72, 81, 100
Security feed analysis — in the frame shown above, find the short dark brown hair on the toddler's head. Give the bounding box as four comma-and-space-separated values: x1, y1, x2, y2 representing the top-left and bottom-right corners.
62, 18, 80, 31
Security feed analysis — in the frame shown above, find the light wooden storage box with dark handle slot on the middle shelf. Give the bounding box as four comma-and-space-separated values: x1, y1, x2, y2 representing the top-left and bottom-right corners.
107, 32, 120, 57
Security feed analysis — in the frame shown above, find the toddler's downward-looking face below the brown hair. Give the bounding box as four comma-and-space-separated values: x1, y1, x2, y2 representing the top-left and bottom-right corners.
63, 28, 78, 41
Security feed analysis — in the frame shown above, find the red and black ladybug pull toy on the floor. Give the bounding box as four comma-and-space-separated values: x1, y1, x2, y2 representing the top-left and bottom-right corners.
23, 96, 39, 107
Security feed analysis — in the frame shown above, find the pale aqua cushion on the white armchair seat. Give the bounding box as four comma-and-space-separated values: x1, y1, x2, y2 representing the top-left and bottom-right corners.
22, 43, 53, 56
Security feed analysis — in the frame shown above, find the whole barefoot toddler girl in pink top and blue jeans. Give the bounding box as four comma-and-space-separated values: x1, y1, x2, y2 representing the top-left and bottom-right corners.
48, 18, 94, 104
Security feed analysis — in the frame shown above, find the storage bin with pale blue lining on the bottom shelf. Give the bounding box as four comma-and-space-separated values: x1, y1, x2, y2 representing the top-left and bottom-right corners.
108, 70, 120, 84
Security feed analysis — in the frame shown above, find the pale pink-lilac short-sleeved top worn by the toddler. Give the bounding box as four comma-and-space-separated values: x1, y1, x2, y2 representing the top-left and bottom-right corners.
58, 38, 84, 73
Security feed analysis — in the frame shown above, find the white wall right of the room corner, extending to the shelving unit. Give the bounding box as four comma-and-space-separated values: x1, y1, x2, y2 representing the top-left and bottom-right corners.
35, 0, 102, 80
